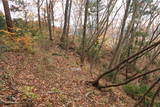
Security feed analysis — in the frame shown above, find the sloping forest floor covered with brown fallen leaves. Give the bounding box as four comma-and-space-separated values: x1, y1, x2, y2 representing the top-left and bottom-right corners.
0, 37, 135, 107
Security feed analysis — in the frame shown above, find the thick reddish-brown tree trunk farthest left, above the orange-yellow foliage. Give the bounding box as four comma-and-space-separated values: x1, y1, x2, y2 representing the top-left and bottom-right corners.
2, 0, 13, 32
